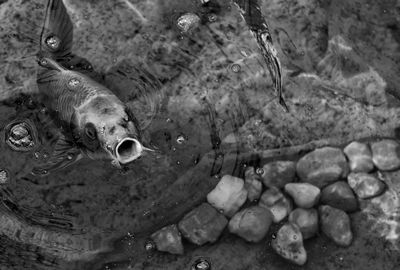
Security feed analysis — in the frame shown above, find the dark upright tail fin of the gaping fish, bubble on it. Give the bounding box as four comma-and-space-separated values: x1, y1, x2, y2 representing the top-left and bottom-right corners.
40, 0, 73, 61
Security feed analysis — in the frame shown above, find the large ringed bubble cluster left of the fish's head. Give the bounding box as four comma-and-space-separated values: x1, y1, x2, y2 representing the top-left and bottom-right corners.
5, 120, 37, 152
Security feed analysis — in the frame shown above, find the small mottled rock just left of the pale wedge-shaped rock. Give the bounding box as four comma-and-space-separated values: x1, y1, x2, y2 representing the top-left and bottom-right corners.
258, 187, 293, 223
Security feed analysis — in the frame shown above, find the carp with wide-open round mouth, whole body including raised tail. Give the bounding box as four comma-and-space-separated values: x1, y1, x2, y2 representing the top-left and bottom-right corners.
36, 0, 150, 168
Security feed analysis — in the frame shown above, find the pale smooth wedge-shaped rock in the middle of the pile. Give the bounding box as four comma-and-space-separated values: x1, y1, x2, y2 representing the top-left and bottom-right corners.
285, 183, 321, 208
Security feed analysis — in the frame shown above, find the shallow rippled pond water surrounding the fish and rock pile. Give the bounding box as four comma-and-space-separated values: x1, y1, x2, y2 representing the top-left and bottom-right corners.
0, 0, 400, 270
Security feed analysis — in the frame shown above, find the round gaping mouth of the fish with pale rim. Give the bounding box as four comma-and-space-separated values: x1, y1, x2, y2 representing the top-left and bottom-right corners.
115, 138, 143, 164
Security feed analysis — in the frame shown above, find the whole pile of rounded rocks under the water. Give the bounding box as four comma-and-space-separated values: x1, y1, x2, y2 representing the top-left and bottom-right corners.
148, 139, 400, 265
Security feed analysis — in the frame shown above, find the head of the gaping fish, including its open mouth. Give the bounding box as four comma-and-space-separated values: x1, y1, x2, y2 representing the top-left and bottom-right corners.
77, 95, 144, 165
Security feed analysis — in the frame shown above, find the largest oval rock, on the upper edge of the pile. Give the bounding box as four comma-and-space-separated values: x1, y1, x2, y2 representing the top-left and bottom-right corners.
296, 147, 349, 188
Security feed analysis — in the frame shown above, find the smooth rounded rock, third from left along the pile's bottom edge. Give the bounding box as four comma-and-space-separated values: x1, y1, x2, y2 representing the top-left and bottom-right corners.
228, 206, 272, 242
